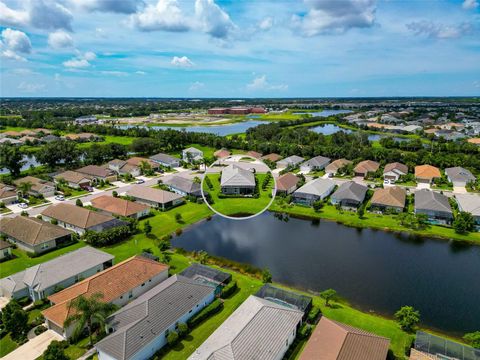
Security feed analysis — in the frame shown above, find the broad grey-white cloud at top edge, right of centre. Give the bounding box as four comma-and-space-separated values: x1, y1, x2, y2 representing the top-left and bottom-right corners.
292, 0, 377, 36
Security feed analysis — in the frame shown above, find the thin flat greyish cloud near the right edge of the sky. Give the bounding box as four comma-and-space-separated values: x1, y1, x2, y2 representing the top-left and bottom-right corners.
406, 20, 473, 39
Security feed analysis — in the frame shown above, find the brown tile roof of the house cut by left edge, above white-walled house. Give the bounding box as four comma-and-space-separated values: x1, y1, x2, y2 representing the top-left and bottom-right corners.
0, 215, 71, 246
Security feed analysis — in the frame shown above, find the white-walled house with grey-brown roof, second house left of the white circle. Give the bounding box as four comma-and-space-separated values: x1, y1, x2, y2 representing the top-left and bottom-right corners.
127, 185, 184, 210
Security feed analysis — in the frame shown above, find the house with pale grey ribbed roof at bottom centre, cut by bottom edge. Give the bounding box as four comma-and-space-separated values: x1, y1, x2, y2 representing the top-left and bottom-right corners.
188, 295, 303, 360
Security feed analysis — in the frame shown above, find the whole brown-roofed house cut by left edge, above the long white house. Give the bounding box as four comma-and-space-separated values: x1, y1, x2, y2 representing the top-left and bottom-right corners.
0, 215, 72, 254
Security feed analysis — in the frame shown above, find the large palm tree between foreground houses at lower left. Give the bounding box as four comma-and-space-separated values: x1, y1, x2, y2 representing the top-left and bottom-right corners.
63, 293, 117, 345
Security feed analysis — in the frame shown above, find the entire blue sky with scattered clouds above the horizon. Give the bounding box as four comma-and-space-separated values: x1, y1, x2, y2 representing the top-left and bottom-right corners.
0, 0, 480, 97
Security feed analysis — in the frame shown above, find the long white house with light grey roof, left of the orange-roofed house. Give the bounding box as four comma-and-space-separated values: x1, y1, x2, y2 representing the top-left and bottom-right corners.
0, 246, 113, 301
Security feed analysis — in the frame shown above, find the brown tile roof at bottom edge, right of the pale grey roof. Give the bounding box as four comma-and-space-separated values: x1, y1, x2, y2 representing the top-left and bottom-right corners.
300, 317, 390, 360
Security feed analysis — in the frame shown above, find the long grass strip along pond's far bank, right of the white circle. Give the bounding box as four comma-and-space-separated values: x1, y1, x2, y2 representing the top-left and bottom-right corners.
269, 199, 480, 244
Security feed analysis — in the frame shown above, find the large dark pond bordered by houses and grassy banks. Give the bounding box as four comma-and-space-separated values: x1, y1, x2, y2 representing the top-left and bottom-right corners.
172, 212, 480, 334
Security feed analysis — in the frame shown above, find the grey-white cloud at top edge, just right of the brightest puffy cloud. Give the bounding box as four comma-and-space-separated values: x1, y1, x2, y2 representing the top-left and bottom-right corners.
195, 0, 237, 39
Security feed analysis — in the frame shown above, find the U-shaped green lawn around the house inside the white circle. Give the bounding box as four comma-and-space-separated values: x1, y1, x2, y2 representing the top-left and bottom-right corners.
203, 174, 273, 216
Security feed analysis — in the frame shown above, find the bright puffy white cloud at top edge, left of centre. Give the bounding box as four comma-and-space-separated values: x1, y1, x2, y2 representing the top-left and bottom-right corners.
130, 0, 191, 31
